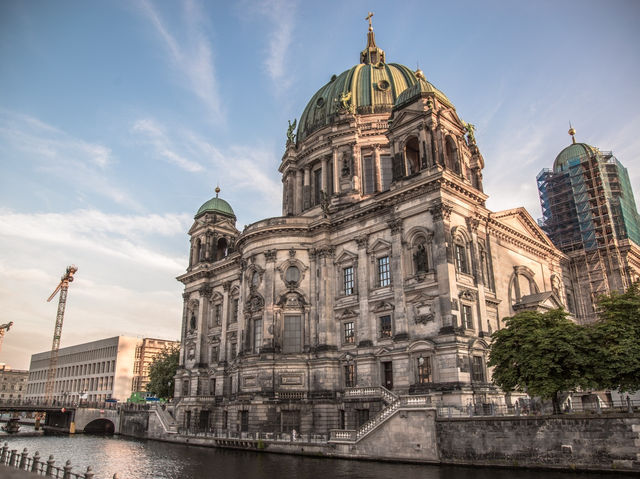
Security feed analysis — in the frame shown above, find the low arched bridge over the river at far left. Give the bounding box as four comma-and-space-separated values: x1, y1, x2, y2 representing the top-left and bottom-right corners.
0, 401, 120, 434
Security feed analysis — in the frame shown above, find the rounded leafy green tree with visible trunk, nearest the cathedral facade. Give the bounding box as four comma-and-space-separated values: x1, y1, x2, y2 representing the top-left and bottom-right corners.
488, 309, 592, 414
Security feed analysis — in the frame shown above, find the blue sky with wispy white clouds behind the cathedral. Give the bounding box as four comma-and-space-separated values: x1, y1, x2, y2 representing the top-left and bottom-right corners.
0, 0, 640, 368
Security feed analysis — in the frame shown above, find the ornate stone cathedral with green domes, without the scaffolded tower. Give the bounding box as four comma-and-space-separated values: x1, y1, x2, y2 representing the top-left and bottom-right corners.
175, 17, 636, 434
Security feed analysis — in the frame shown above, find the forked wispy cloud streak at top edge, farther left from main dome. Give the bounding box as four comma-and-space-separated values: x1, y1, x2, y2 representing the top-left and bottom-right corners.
139, 0, 223, 120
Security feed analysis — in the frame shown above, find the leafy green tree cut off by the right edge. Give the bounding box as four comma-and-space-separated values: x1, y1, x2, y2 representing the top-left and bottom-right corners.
588, 283, 640, 392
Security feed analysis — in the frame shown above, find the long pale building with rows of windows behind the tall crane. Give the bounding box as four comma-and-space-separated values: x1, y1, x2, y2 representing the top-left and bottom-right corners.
25, 336, 143, 402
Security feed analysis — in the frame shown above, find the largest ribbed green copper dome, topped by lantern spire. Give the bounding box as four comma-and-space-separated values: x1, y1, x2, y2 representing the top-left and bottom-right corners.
297, 24, 428, 141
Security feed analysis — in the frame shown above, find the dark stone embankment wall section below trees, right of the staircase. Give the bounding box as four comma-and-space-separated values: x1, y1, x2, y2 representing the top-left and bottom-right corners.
436, 415, 640, 470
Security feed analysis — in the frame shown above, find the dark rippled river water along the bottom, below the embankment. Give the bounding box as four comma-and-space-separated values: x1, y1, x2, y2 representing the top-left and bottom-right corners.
0, 435, 624, 479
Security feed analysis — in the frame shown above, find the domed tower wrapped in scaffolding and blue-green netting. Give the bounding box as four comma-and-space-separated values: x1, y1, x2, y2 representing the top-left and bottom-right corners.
537, 128, 640, 322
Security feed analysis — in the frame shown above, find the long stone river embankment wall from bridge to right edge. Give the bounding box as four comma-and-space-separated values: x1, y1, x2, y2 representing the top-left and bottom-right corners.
120, 410, 640, 473
